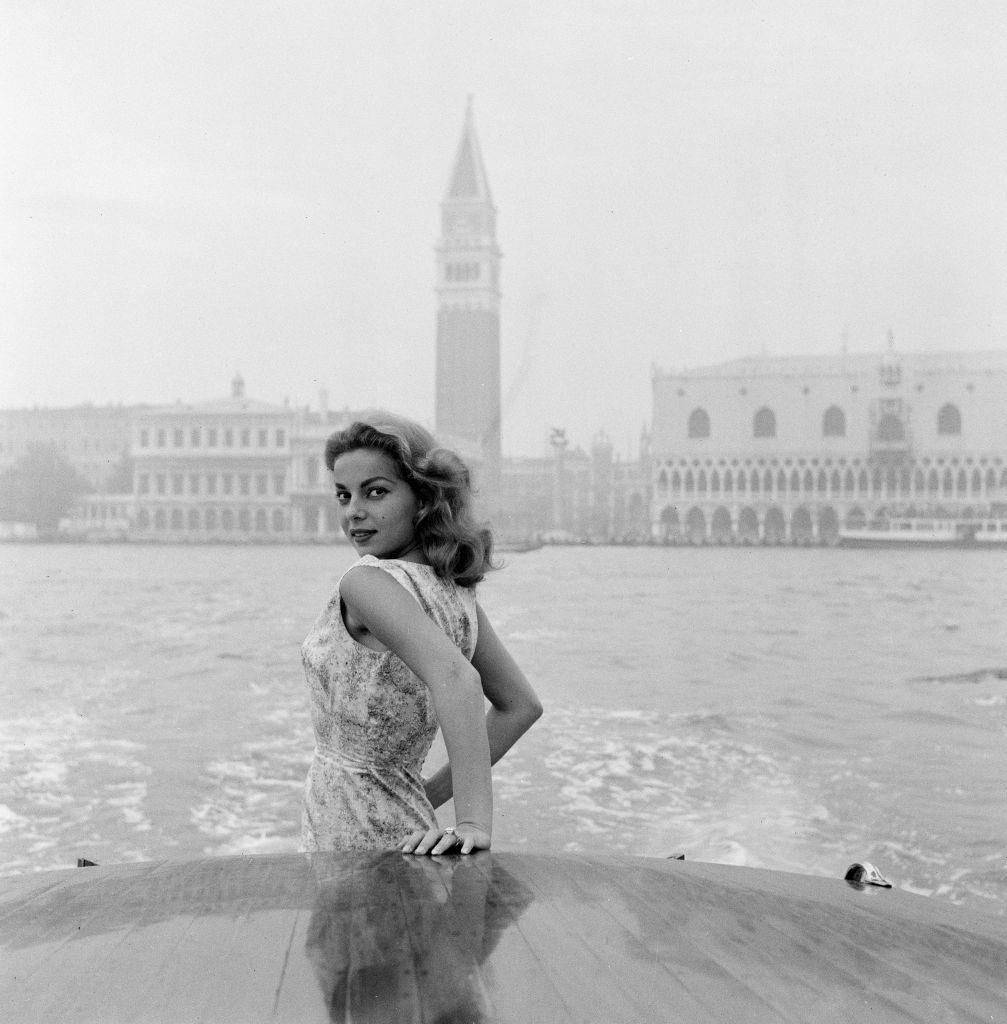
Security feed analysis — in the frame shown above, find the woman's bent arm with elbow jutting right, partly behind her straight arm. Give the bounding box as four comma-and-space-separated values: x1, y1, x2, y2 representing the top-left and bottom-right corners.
424, 605, 542, 807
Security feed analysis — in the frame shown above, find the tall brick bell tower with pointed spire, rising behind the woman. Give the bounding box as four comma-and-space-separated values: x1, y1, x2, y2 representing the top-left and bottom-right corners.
435, 96, 501, 518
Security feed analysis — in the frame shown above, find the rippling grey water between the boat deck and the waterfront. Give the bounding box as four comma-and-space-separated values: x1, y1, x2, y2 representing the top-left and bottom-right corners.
0, 545, 1007, 914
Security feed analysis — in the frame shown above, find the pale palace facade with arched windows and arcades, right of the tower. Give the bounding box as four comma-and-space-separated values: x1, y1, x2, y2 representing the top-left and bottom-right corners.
651, 342, 1007, 544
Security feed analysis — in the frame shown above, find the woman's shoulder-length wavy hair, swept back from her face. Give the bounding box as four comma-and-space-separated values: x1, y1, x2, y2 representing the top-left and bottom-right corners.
325, 413, 497, 587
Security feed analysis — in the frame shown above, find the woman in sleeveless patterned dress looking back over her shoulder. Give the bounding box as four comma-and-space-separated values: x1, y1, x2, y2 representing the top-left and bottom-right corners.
301, 414, 542, 854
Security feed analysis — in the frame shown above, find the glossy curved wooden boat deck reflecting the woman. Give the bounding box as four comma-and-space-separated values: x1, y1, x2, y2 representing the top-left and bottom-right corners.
0, 853, 1007, 1024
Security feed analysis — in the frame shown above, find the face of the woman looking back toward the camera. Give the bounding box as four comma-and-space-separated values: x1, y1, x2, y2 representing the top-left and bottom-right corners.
332, 449, 426, 562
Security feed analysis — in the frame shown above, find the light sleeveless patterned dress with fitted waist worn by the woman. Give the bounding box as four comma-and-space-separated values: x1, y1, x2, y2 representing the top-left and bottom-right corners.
301, 555, 476, 852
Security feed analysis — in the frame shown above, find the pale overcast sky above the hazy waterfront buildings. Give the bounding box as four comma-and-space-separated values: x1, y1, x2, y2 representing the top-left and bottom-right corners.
0, 0, 1007, 455
